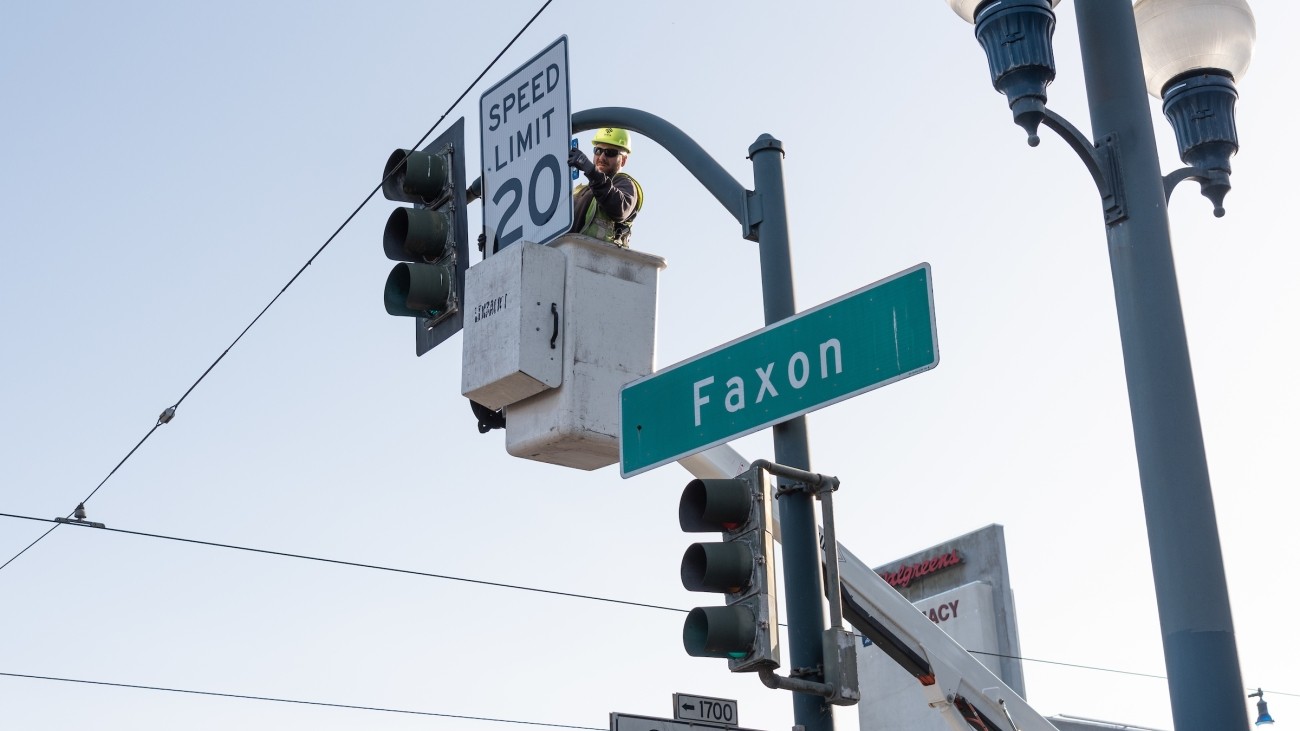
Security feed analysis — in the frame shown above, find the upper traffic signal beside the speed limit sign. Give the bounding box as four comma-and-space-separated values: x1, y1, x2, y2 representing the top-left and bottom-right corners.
382, 117, 469, 355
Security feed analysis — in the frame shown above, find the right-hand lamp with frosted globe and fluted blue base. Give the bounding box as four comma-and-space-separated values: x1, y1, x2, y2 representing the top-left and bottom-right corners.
1134, 0, 1255, 216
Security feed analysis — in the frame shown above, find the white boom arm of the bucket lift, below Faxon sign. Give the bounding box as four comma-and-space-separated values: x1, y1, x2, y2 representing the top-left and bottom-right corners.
677, 445, 1057, 731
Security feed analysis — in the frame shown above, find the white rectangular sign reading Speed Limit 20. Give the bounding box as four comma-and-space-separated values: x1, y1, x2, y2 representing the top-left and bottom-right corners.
478, 35, 573, 254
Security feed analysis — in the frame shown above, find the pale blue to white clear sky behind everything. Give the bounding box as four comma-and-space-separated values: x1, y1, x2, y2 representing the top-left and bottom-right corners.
0, 0, 1300, 731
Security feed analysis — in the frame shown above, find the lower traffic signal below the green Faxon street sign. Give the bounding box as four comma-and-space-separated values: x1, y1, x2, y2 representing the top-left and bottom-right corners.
677, 468, 781, 672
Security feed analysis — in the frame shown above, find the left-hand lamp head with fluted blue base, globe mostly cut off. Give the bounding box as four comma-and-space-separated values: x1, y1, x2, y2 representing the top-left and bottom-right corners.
948, 0, 1060, 147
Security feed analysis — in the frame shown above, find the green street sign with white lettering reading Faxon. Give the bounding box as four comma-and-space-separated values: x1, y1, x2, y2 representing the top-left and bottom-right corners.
619, 264, 939, 477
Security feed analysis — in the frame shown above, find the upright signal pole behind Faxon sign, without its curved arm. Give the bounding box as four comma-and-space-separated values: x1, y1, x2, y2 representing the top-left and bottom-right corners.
746, 134, 839, 731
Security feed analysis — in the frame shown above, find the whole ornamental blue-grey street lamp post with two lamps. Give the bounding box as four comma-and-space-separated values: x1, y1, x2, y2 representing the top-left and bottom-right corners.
948, 0, 1255, 731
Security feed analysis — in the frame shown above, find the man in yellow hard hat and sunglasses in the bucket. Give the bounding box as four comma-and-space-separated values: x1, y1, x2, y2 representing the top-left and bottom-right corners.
568, 127, 645, 248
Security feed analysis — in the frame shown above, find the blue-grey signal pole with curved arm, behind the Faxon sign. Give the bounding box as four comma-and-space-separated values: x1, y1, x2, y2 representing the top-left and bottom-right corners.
572, 107, 835, 731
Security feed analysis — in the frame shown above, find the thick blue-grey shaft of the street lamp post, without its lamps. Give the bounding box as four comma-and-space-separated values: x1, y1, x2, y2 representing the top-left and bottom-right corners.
1074, 0, 1249, 731
